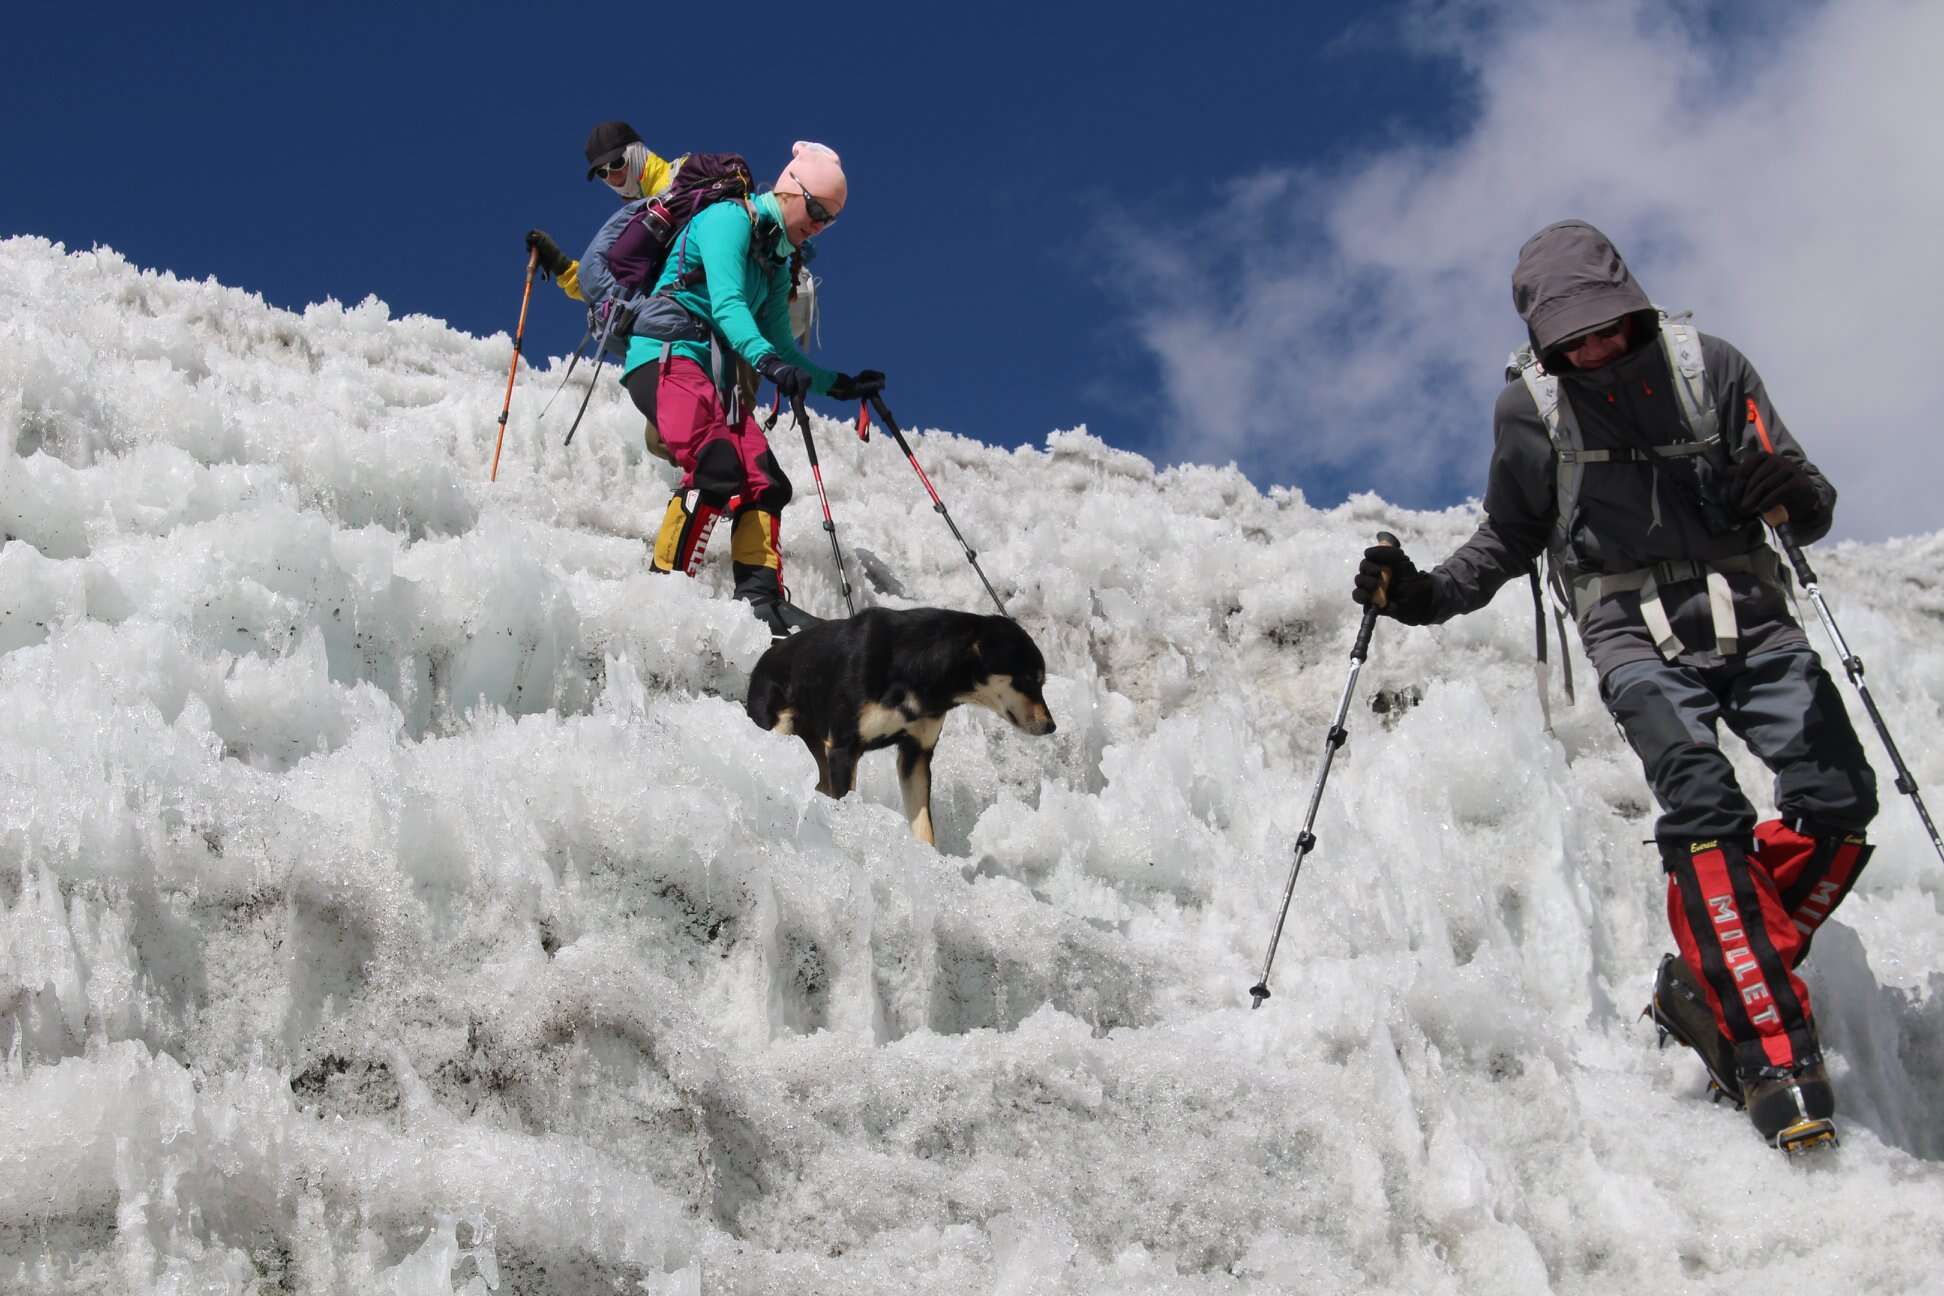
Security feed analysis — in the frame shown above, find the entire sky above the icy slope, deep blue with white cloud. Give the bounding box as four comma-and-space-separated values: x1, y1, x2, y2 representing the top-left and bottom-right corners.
0, 0, 1944, 538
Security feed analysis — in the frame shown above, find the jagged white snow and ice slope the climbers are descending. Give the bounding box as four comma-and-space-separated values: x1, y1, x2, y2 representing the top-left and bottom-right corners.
11, 239, 1944, 1294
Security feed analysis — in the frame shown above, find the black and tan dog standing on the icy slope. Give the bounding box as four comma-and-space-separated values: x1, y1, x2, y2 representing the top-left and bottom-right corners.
746, 608, 1054, 843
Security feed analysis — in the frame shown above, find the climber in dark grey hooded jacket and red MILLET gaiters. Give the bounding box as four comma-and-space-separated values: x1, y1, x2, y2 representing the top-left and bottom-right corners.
1353, 222, 1876, 1144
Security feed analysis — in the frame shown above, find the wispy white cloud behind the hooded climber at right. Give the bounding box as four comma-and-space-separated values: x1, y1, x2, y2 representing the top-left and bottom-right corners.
1120, 0, 1944, 538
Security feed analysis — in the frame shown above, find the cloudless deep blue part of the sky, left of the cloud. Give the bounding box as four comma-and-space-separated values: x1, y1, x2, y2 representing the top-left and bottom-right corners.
0, 4, 1450, 497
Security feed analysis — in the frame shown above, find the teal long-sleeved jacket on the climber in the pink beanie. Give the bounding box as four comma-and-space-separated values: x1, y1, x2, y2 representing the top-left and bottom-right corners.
626, 194, 838, 394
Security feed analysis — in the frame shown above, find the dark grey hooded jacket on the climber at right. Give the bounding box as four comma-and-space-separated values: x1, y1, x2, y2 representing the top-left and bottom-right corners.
1431, 222, 1835, 678
